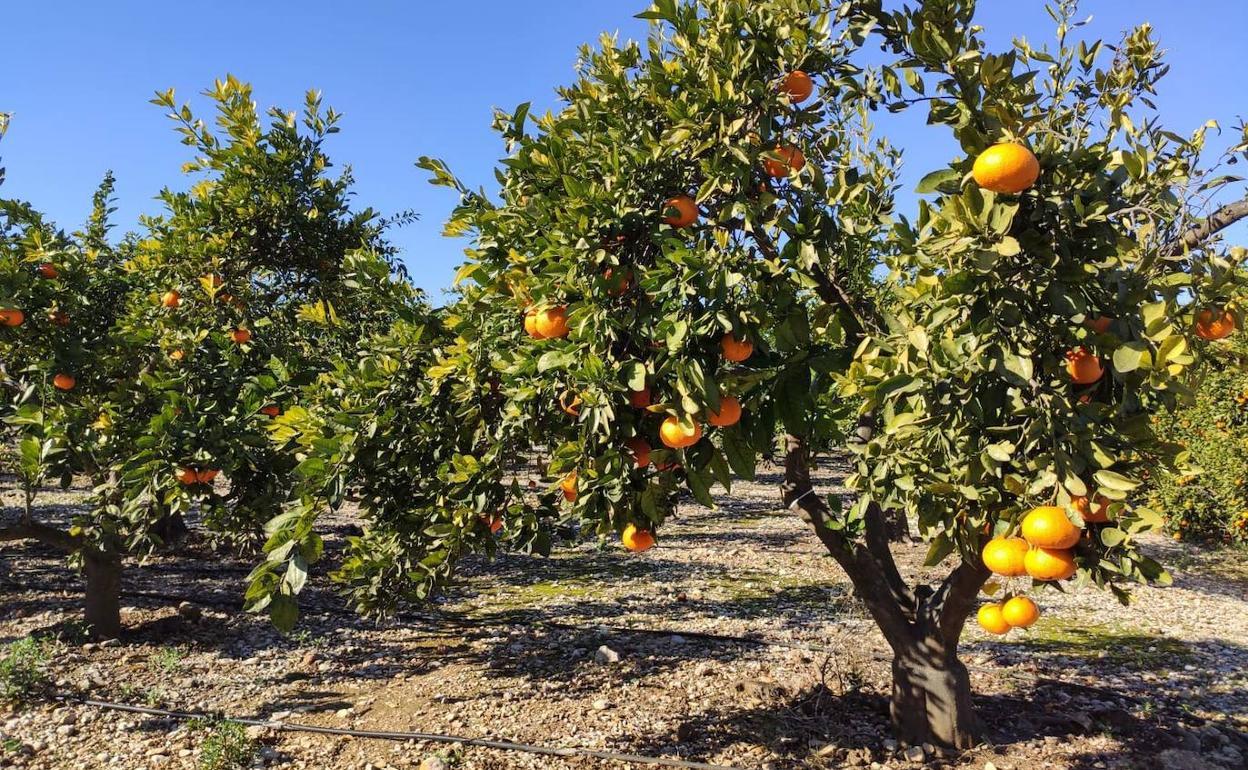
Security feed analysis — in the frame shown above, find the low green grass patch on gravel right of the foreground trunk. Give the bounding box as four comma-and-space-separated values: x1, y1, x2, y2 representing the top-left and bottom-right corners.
1021, 618, 1193, 671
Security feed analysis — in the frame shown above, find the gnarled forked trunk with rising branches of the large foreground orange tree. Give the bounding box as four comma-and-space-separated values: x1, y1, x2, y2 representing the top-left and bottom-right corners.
781, 434, 988, 749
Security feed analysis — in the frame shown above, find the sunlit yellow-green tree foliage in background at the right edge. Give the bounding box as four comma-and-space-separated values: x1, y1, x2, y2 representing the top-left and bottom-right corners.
1147, 326, 1248, 544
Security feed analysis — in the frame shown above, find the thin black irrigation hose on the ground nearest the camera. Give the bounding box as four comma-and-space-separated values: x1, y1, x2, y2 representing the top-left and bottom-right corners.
74, 699, 745, 770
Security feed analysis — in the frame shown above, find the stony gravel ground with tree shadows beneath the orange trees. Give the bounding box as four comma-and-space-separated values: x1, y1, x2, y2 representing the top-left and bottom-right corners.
0, 461, 1248, 770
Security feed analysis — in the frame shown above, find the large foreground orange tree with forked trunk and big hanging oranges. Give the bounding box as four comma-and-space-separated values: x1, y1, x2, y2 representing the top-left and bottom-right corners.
245, 0, 1248, 746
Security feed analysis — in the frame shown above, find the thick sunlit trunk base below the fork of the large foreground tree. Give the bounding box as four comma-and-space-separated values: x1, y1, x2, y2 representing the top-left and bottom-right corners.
889, 638, 980, 749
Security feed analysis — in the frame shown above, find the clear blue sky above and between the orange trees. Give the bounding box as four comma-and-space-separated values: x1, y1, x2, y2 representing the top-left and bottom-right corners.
0, 0, 1248, 296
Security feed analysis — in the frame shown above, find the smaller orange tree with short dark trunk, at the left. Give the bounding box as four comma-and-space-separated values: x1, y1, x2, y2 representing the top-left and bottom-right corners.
0, 79, 413, 635
